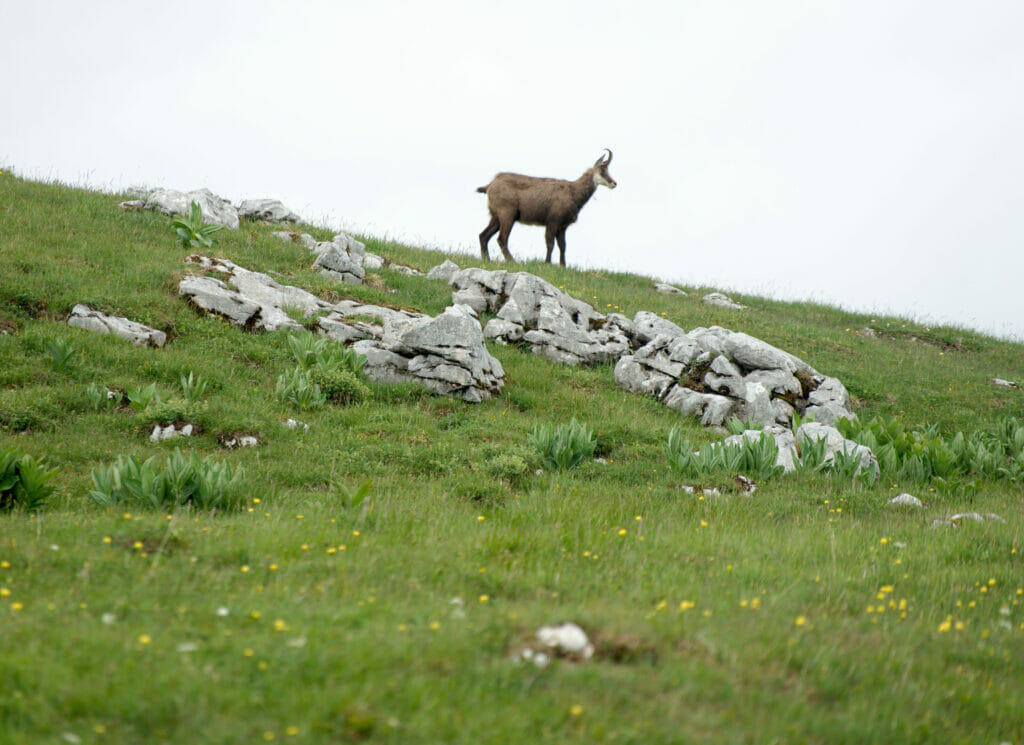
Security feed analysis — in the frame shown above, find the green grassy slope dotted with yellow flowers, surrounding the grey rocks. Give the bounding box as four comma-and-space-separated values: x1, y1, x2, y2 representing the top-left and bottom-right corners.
0, 173, 1024, 743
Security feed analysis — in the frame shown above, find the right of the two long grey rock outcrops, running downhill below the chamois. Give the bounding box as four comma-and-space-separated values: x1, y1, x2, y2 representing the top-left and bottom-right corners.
431, 262, 853, 427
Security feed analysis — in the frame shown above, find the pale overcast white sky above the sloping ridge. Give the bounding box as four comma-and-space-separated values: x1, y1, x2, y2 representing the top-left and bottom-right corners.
0, 0, 1024, 339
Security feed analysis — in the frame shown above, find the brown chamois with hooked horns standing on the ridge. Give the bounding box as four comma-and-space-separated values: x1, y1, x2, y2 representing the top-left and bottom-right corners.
476, 150, 615, 266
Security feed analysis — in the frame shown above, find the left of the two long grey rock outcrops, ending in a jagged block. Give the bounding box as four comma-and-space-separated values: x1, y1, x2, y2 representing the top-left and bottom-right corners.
178, 256, 505, 403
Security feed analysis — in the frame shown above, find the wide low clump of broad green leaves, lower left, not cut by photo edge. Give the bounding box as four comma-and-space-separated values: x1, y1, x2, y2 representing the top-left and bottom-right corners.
89, 450, 246, 510
